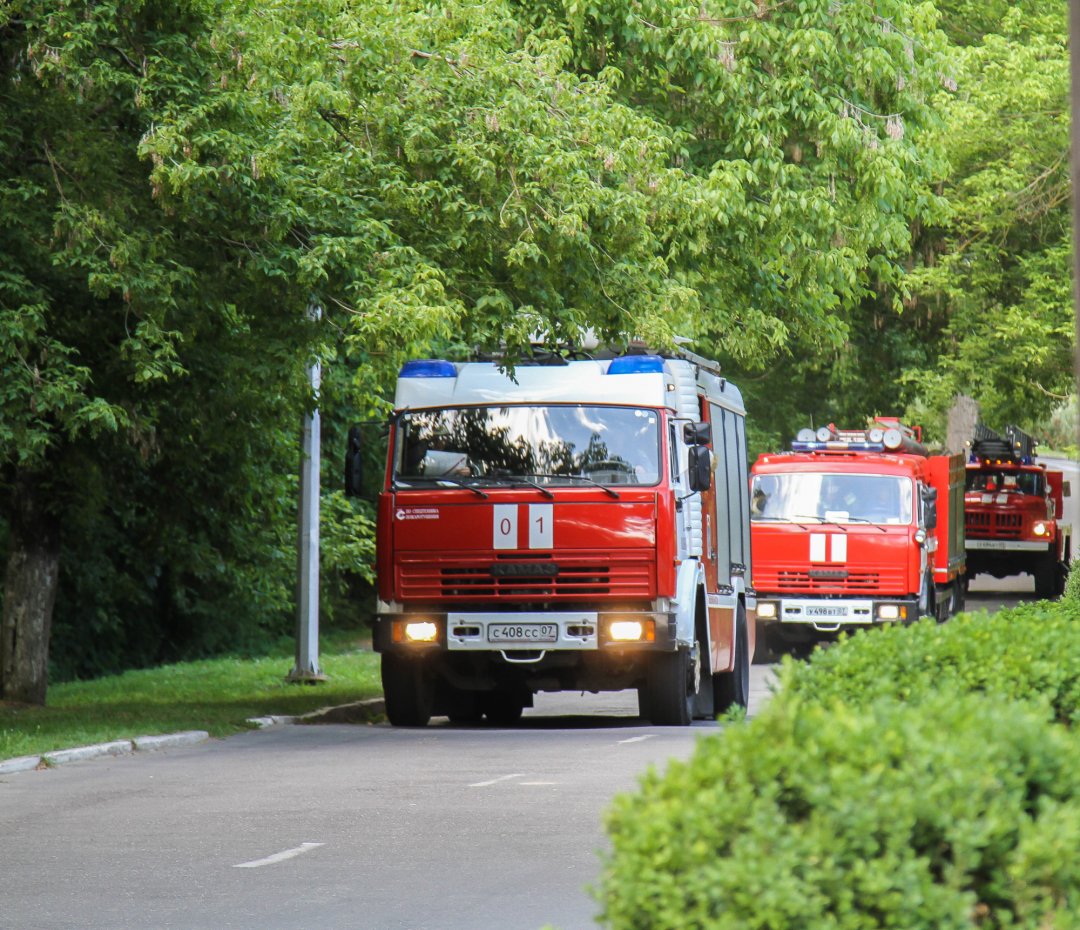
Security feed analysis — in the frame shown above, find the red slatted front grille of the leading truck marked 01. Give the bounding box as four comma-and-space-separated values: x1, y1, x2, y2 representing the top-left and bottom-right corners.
397, 553, 656, 602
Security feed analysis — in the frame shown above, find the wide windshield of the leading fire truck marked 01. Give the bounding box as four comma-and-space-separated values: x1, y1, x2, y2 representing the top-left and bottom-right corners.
393, 404, 660, 487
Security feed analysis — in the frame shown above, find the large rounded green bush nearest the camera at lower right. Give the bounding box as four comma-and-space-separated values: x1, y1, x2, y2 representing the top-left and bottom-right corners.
597, 695, 1080, 930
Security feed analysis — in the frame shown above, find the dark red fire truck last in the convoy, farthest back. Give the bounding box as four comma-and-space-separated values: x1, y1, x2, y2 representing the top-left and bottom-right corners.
964, 423, 1072, 597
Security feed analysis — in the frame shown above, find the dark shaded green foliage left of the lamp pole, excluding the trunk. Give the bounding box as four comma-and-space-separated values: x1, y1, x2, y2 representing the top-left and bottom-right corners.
0, 0, 316, 680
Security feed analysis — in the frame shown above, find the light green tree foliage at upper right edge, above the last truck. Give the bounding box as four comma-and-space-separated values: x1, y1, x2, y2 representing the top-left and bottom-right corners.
905, 0, 1075, 423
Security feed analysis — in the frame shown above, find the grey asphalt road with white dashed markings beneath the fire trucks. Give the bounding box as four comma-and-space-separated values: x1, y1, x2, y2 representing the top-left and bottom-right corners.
0, 576, 1045, 930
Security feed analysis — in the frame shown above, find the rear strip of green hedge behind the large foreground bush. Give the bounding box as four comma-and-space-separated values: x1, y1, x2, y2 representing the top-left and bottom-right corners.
780, 597, 1080, 725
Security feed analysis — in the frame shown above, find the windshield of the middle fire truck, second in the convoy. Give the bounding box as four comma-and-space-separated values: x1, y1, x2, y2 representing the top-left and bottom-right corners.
751, 472, 912, 525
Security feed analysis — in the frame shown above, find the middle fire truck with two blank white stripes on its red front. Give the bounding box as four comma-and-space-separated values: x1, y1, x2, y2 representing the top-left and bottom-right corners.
751, 417, 964, 651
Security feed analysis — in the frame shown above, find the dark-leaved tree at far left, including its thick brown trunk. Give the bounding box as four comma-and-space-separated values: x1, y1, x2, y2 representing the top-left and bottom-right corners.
0, 0, 315, 703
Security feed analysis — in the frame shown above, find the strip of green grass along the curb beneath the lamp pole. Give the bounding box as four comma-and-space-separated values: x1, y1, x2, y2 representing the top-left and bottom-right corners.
0, 633, 382, 760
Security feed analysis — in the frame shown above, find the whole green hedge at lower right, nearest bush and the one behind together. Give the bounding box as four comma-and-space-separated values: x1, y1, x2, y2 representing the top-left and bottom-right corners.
597, 571, 1080, 930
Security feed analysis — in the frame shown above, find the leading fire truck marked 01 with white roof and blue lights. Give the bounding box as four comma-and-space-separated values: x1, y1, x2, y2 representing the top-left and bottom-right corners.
346, 352, 754, 726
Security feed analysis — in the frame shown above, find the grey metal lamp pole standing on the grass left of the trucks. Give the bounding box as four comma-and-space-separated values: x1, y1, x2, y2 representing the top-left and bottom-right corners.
286, 304, 326, 683
